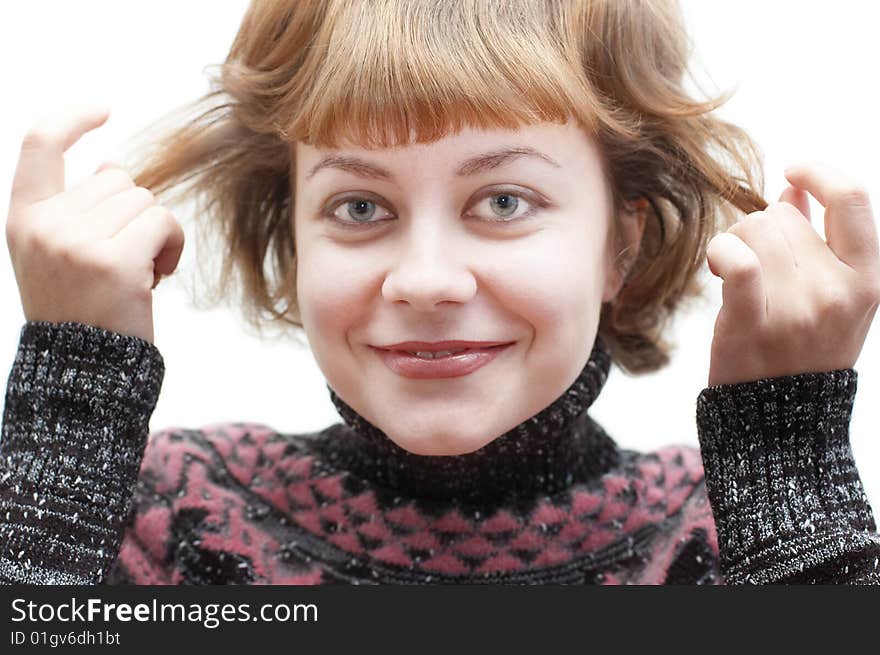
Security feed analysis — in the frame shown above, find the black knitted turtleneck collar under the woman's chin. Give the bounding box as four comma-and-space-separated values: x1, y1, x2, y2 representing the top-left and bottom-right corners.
316, 338, 620, 506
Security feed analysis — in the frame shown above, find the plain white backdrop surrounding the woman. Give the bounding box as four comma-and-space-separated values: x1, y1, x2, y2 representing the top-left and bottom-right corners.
0, 0, 880, 508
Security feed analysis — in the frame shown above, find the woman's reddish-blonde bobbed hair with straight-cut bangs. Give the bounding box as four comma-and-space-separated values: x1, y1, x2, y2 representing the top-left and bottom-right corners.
131, 0, 766, 373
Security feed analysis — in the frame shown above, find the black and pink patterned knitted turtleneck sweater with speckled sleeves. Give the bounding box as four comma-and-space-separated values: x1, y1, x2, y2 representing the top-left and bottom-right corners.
0, 323, 880, 584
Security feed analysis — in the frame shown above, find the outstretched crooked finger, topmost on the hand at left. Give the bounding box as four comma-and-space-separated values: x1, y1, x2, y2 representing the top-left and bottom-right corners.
10, 106, 110, 206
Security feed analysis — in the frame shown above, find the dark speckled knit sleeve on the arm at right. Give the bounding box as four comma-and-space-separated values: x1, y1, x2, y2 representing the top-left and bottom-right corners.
697, 369, 880, 584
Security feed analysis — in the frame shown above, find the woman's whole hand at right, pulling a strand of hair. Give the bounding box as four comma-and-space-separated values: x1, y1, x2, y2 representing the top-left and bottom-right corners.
707, 163, 880, 386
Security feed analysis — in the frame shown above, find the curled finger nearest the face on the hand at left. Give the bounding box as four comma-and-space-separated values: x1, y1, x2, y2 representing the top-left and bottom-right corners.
114, 205, 185, 275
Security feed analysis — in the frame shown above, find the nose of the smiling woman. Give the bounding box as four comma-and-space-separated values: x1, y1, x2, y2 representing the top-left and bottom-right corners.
382, 230, 477, 312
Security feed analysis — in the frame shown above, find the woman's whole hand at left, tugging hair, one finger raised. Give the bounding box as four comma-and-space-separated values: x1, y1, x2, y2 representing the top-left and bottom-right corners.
6, 108, 184, 342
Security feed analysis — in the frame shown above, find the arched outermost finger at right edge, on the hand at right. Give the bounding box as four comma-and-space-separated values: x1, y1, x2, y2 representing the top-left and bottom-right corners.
785, 163, 880, 270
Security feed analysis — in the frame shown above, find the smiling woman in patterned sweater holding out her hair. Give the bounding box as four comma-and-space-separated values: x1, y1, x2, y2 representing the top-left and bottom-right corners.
0, 0, 880, 584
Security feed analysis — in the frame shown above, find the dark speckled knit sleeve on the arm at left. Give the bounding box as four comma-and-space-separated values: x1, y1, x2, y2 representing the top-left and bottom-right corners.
0, 322, 165, 584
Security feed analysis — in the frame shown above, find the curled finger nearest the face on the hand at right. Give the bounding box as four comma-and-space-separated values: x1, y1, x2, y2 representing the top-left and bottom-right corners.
706, 232, 767, 321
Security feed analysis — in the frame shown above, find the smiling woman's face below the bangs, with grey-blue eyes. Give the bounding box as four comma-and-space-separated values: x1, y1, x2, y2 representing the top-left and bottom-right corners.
291, 123, 619, 455
